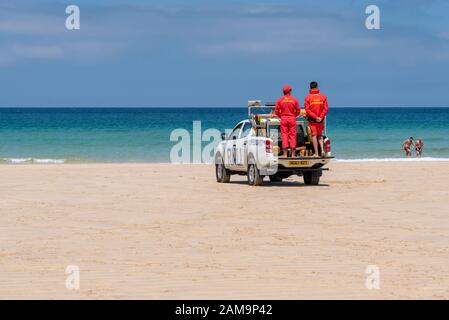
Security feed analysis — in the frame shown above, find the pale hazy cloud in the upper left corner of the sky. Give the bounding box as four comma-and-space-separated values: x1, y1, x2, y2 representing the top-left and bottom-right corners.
0, 1, 130, 66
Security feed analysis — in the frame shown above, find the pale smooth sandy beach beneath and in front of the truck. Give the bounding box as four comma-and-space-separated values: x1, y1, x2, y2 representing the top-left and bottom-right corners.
0, 162, 449, 299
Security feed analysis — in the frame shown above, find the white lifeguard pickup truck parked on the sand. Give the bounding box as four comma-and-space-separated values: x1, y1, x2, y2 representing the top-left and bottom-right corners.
215, 101, 333, 186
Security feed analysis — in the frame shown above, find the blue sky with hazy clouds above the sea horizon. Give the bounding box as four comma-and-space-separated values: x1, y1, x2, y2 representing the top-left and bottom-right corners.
0, 0, 449, 107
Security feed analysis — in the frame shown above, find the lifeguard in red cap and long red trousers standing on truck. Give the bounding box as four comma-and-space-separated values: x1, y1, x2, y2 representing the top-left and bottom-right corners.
274, 86, 301, 157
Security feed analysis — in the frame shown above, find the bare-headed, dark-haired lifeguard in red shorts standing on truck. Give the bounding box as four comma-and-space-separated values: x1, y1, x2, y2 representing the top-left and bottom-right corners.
304, 81, 329, 157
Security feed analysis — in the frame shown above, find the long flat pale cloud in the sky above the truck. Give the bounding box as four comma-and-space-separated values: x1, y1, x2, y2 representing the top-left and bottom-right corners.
192, 14, 379, 55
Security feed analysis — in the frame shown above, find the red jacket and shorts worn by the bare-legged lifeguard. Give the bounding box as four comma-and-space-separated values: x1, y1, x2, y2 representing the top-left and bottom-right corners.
304, 89, 329, 136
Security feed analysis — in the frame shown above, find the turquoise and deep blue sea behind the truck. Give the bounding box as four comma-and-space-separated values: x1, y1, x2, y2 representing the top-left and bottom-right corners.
0, 108, 449, 163
